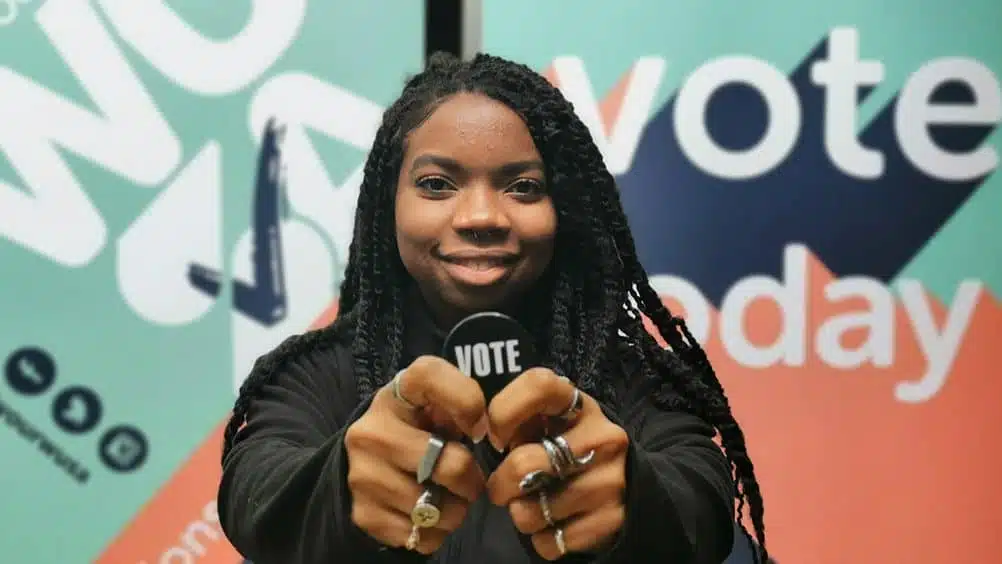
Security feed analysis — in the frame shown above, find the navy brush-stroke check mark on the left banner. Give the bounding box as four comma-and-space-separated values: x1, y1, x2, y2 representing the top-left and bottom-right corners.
188, 119, 288, 327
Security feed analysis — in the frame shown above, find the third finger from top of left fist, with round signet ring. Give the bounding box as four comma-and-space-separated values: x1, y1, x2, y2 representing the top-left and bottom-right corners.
348, 454, 468, 531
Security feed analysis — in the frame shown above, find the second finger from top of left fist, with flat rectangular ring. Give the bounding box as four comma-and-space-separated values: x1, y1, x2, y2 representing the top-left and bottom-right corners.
345, 417, 486, 502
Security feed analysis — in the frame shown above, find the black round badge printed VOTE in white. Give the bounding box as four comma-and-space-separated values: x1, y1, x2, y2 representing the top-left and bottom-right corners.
442, 312, 539, 403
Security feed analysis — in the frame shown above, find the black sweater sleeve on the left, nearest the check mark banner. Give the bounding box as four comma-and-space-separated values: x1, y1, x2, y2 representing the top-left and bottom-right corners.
218, 338, 413, 564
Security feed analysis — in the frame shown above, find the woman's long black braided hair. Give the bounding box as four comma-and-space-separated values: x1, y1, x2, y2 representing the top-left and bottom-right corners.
223, 53, 768, 560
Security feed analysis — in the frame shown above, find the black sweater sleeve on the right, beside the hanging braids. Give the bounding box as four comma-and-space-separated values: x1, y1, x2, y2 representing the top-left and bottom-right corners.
598, 376, 734, 564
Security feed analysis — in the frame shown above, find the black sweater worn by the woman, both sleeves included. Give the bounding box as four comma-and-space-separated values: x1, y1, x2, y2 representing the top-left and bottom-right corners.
218, 298, 734, 564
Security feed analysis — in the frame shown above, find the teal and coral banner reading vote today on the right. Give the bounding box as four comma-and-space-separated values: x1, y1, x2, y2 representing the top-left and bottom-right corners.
484, 0, 1002, 564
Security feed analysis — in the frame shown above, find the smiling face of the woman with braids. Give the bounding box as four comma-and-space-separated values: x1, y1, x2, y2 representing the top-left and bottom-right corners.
396, 93, 557, 323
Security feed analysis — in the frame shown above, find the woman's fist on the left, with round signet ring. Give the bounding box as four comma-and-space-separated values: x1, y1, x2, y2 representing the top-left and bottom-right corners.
345, 357, 487, 554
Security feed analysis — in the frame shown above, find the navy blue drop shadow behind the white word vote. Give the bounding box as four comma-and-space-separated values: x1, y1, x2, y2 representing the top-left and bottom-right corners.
617, 35, 994, 306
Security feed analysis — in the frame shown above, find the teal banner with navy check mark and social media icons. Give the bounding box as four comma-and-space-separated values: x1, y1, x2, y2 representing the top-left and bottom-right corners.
0, 0, 424, 564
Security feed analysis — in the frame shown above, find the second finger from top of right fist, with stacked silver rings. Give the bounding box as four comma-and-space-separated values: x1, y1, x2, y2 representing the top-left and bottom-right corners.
487, 412, 629, 506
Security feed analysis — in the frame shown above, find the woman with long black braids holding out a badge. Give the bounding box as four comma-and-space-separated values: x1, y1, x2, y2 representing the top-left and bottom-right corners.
218, 55, 765, 564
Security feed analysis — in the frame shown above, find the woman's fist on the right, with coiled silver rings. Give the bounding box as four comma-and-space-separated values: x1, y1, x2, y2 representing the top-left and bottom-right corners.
487, 369, 629, 560
